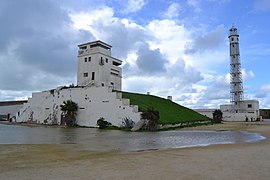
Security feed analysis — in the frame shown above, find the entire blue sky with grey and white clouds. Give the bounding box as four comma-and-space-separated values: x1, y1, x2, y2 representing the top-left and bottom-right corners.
0, 0, 270, 108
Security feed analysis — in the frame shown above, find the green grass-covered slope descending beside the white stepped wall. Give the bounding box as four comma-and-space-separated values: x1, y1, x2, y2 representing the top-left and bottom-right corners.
122, 92, 210, 124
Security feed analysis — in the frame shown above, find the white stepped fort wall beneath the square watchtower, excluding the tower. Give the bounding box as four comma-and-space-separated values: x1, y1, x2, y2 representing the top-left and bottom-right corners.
17, 86, 140, 127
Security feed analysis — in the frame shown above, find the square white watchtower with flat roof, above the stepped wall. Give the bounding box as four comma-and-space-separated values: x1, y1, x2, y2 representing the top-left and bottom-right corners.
77, 40, 122, 90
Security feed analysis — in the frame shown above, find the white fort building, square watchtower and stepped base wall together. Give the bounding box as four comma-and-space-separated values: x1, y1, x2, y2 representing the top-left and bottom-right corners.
16, 41, 141, 127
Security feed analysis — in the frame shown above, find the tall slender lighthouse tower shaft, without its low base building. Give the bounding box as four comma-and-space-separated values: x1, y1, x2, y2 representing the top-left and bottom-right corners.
229, 26, 243, 113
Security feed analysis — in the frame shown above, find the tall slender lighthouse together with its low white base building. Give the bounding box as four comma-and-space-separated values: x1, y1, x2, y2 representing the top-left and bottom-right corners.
220, 26, 261, 121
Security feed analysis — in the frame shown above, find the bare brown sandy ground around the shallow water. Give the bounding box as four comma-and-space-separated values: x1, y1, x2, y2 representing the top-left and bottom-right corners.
0, 122, 270, 180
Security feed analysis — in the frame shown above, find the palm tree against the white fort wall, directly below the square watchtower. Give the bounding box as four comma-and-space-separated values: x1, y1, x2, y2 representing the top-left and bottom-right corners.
60, 100, 78, 126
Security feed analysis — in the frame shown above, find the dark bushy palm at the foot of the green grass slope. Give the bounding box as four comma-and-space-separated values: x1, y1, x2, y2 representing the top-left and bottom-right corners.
141, 107, 159, 131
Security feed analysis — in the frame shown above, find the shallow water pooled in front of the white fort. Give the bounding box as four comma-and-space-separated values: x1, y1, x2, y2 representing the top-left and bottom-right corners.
0, 124, 265, 151
